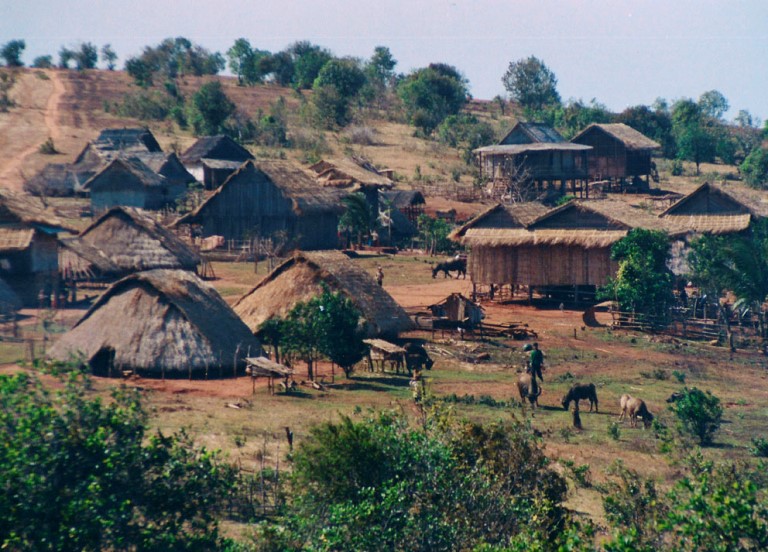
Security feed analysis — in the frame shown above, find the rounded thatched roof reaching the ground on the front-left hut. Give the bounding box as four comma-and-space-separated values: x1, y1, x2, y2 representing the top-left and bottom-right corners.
48, 270, 261, 377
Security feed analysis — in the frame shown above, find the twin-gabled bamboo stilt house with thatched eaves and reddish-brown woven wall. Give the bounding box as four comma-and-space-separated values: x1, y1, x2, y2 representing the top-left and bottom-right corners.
451, 200, 676, 290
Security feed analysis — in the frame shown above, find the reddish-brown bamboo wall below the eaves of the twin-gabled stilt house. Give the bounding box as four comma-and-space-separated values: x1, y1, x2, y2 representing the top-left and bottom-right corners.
468, 245, 618, 286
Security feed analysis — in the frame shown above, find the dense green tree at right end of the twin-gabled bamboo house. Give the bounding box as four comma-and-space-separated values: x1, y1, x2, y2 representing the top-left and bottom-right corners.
600, 228, 673, 324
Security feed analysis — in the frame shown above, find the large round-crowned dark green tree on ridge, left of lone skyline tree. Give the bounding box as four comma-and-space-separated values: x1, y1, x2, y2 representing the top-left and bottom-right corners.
397, 63, 469, 136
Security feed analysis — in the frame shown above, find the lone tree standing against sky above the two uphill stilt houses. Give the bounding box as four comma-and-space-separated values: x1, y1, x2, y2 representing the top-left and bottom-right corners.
501, 56, 560, 113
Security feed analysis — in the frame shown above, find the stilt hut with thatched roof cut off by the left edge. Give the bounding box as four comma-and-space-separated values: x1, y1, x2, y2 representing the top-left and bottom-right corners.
0, 189, 74, 307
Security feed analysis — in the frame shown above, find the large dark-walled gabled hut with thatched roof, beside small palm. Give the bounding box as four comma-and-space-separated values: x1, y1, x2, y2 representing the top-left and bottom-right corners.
175, 161, 343, 250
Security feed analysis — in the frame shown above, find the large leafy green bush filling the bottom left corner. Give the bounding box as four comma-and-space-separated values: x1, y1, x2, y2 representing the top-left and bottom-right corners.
0, 372, 234, 550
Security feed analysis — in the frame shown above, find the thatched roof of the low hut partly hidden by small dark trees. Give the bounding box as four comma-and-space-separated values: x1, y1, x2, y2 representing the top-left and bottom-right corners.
234, 251, 413, 337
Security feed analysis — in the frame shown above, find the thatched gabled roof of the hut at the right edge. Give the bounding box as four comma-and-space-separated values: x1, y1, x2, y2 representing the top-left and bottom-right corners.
661, 182, 768, 234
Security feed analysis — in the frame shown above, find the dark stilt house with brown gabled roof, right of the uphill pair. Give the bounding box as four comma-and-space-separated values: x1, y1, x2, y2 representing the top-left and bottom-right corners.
571, 123, 661, 188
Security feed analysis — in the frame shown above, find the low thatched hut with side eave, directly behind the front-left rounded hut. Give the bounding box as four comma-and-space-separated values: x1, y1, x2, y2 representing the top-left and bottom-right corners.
62, 207, 200, 278
